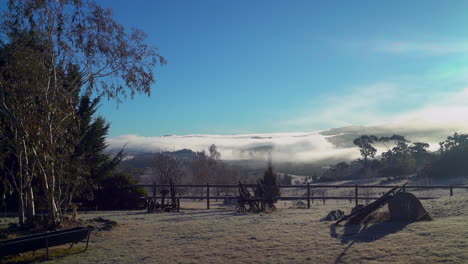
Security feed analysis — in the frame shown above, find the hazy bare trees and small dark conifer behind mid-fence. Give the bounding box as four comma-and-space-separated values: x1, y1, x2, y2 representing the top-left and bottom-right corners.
146, 144, 286, 202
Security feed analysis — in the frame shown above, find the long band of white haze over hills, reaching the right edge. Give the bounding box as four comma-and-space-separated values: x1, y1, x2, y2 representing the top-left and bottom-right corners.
107, 121, 466, 164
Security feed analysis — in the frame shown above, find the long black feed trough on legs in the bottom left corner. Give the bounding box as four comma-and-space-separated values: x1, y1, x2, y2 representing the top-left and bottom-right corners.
0, 227, 91, 257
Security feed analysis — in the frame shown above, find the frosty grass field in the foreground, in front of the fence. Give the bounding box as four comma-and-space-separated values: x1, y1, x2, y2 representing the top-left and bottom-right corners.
0, 195, 468, 264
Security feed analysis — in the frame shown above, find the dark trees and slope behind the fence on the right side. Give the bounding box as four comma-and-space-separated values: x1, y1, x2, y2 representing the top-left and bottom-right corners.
316, 133, 468, 181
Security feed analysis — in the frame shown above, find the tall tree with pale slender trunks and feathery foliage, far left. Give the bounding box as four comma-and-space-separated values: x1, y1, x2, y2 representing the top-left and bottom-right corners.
0, 0, 166, 226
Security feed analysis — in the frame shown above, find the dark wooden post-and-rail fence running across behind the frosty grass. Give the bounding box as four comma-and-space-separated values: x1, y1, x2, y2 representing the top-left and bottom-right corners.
133, 183, 468, 209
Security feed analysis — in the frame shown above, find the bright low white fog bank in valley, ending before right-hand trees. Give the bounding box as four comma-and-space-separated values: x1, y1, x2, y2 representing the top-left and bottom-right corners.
107, 132, 358, 161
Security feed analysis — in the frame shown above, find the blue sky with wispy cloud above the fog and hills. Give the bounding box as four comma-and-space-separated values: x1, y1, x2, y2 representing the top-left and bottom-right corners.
96, 0, 468, 137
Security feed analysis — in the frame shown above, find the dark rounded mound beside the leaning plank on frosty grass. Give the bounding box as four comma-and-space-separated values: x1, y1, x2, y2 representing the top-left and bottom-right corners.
388, 192, 431, 222
